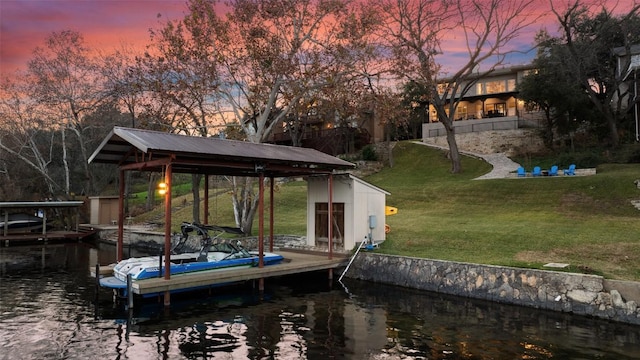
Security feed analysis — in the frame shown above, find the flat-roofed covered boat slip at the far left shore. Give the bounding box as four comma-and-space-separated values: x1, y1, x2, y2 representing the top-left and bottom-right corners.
0, 201, 95, 245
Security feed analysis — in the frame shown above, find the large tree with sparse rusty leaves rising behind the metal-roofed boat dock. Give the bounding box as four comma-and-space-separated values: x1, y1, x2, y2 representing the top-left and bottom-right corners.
135, 0, 373, 233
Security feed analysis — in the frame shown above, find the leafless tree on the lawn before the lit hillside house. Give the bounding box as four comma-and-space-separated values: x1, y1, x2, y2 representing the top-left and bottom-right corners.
375, 0, 536, 173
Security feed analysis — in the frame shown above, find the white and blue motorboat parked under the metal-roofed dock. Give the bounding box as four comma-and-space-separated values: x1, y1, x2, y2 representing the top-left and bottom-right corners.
100, 223, 283, 297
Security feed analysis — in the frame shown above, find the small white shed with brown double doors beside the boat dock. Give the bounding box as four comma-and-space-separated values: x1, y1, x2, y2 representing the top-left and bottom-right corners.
307, 174, 390, 251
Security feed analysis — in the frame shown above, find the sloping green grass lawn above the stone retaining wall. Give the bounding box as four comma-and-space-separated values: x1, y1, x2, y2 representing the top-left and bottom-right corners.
131, 142, 640, 281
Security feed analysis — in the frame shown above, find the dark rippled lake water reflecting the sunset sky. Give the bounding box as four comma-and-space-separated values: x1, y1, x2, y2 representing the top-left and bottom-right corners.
0, 244, 640, 359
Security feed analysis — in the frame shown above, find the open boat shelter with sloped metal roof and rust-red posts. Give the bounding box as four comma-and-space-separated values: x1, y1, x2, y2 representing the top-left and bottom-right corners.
89, 127, 354, 305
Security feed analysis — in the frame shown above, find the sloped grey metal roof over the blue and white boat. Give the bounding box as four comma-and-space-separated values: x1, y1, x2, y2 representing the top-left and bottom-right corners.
89, 127, 355, 177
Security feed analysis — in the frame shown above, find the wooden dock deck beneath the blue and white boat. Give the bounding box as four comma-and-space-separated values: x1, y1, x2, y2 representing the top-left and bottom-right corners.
92, 250, 347, 295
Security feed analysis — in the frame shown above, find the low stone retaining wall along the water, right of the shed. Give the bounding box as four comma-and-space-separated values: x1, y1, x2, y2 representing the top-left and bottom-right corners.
346, 253, 640, 325
